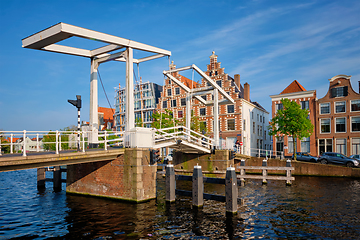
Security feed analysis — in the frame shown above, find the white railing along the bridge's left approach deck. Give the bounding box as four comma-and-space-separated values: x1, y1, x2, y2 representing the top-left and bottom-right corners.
0, 130, 125, 156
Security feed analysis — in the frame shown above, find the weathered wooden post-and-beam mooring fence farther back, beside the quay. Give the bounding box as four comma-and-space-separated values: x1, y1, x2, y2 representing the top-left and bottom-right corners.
237, 159, 295, 186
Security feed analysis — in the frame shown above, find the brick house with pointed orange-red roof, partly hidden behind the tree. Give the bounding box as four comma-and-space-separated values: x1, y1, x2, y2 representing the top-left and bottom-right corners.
270, 80, 317, 157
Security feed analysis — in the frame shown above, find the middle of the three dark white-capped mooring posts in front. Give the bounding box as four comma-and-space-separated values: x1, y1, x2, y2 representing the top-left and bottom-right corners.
192, 165, 204, 207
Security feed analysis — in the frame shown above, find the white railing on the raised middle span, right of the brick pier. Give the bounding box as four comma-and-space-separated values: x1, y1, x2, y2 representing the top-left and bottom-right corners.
154, 126, 215, 149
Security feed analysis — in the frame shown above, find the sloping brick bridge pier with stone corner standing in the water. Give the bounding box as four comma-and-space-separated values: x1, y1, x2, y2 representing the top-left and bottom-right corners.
66, 149, 156, 202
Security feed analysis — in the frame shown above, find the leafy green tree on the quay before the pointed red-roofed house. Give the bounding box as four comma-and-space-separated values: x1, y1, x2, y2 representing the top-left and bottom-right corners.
269, 98, 314, 160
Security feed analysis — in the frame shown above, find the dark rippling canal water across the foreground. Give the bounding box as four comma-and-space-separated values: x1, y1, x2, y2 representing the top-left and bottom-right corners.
0, 169, 360, 239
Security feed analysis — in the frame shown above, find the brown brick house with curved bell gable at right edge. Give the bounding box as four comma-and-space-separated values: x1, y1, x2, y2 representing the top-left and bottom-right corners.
315, 75, 360, 156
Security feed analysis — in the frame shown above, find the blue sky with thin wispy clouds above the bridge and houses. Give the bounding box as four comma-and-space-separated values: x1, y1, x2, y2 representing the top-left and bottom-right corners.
0, 0, 360, 131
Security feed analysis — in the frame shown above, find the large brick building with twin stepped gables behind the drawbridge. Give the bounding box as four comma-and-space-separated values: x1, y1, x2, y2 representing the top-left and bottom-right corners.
157, 52, 271, 155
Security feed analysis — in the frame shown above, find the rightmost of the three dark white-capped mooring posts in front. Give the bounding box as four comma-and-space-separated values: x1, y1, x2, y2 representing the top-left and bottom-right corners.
225, 167, 238, 213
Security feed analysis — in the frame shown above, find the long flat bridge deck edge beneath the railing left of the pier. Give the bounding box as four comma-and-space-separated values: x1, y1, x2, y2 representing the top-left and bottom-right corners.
0, 148, 125, 172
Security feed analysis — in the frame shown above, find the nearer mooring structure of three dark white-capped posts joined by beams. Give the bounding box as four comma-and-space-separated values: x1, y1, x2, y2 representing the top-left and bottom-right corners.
165, 165, 240, 213
